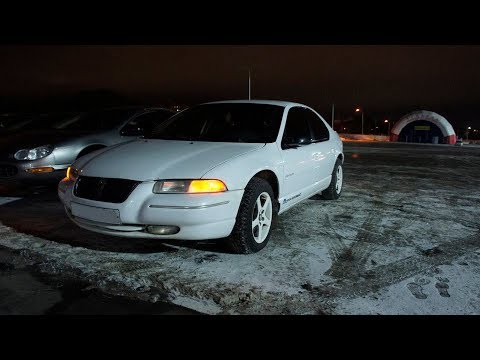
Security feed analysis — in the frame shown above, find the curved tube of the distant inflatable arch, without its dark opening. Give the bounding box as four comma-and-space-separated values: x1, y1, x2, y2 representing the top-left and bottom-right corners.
390, 110, 457, 144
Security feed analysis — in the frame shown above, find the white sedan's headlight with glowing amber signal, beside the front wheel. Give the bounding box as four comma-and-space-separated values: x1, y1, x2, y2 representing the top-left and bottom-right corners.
153, 179, 227, 194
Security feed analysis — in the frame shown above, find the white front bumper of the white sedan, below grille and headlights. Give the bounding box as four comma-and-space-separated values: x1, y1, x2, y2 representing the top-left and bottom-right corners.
58, 179, 243, 240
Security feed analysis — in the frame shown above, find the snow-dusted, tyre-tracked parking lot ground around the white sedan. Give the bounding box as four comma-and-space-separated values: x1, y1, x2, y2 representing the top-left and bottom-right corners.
0, 142, 480, 314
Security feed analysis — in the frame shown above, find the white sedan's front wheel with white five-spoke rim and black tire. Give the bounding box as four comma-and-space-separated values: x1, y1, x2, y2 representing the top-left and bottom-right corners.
229, 177, 277, 254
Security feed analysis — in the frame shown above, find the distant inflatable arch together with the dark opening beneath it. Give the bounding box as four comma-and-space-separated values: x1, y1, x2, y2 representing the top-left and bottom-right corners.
390, 110, 457, 144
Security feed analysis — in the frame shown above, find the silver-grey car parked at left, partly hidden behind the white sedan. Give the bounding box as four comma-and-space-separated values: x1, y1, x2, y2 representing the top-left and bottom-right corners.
0, 107, 173, 182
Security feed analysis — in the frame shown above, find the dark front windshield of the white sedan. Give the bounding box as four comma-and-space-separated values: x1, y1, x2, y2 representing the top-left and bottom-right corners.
149, 103, 284, 143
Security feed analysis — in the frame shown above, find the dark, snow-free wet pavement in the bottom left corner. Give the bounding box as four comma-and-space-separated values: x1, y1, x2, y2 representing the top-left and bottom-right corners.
0, 248, 198, 315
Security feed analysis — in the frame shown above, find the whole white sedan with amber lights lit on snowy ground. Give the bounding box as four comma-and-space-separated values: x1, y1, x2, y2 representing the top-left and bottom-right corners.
58, 100, 344, 253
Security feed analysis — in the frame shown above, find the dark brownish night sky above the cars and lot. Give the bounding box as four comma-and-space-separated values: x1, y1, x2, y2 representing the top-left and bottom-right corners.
0, 45, 480, 131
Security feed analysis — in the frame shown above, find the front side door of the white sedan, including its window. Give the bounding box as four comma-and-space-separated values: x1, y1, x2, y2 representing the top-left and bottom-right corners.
280, 107, 316, 208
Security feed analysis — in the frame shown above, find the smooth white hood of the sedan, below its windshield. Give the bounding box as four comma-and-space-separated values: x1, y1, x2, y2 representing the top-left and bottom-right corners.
80, 139, 264, 181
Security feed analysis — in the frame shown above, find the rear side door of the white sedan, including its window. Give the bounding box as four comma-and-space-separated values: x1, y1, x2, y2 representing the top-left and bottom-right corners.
303, 108, 336, 187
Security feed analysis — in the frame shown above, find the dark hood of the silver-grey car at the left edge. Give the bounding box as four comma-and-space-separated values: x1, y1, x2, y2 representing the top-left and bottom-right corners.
0, 130, 93, 159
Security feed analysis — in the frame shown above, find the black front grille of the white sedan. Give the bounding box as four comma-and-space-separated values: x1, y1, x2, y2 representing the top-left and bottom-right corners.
73, 176, 140, 203
